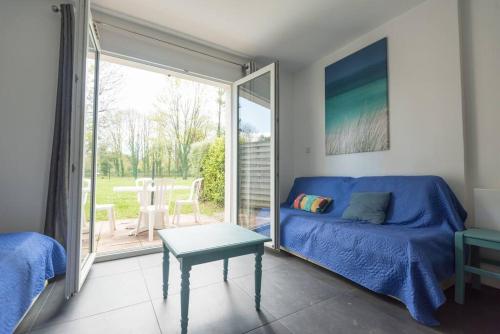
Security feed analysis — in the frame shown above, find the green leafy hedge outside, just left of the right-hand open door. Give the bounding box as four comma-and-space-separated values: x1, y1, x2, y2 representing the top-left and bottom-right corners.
200, 137, 225, 206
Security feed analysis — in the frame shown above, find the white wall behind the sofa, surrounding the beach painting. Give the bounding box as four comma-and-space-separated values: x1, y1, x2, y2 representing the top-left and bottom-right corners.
293, 0, 465, 199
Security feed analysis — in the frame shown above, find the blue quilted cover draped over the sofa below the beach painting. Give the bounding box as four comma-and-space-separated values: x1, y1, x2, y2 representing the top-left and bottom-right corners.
261, 176, 467, 325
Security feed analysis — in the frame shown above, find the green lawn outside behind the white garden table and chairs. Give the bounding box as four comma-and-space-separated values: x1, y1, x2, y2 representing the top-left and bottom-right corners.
86, 177, 224, 221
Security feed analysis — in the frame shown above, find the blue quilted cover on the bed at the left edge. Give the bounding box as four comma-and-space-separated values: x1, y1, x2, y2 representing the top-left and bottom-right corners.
0, 232, 66, 334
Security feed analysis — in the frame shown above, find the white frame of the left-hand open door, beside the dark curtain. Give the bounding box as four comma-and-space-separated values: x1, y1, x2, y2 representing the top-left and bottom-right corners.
65, 0, 101, 298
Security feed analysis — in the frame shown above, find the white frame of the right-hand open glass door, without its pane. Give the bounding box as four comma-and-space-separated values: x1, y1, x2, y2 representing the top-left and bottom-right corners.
229, 61, 280, 250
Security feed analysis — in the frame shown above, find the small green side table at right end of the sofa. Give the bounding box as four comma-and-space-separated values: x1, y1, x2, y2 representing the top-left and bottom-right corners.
455, 228, 500, 304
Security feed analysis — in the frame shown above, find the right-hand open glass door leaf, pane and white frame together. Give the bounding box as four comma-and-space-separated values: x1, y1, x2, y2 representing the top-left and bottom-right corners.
233, 64, 279, 248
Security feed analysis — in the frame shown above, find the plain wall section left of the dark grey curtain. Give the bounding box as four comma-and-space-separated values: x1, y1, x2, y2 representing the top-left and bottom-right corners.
0, 0, 60, 232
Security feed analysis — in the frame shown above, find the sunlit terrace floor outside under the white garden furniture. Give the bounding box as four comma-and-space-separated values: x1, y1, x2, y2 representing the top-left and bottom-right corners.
83, 212, 224, 255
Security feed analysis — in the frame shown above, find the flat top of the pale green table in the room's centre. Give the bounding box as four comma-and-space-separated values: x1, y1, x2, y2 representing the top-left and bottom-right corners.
158, 223, 271, 257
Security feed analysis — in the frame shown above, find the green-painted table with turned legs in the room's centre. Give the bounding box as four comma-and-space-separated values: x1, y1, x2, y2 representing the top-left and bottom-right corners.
158, 224, 271, 333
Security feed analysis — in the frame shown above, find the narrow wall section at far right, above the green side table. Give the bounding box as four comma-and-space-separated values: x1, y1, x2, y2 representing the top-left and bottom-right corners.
461, 0, 500, 222
